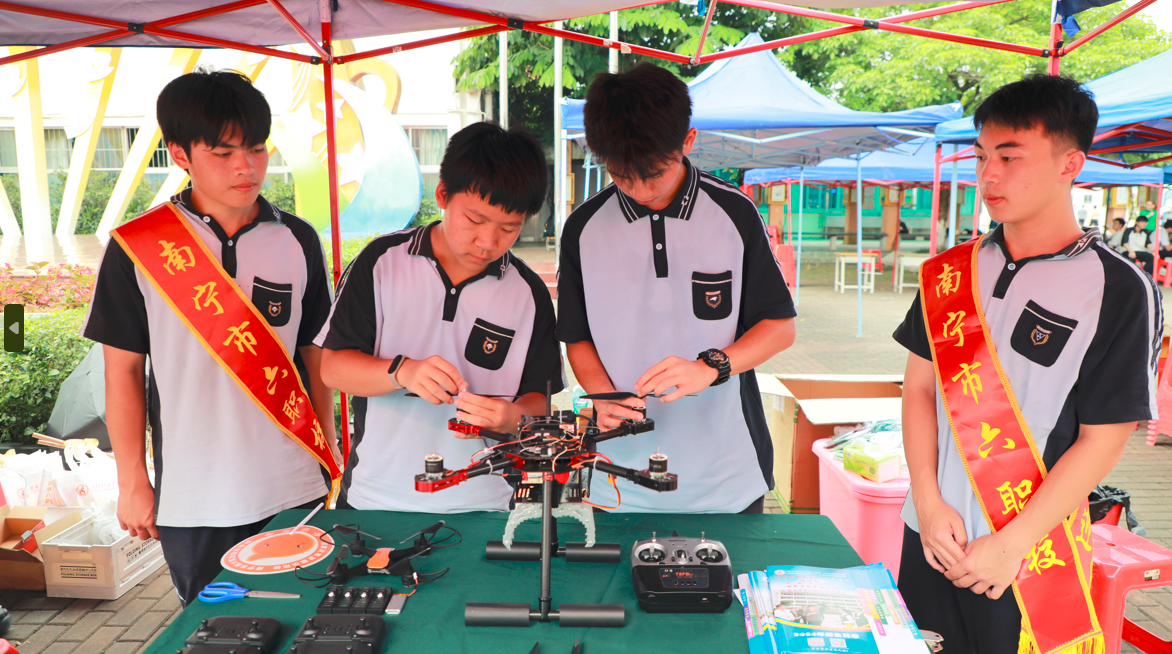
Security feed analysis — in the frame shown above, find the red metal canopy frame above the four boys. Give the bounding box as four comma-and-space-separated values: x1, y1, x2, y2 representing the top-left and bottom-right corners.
0, 0, 1156, 458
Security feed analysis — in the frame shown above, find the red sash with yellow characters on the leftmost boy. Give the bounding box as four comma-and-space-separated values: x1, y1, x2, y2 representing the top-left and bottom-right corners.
110, 203, 342, 505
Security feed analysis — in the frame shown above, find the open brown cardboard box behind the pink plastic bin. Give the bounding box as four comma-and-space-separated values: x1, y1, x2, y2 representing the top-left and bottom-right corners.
758, 375, 904, 513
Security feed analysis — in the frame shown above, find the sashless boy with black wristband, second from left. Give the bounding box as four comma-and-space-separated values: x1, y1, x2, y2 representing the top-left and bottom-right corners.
318, 123, 565, 513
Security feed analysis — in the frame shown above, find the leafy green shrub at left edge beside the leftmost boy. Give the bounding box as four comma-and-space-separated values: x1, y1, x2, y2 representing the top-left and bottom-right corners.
0, 308, 93, 443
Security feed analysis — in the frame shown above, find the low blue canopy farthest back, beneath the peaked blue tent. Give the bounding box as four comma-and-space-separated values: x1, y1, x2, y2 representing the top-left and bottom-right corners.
744, 143, 1166, 186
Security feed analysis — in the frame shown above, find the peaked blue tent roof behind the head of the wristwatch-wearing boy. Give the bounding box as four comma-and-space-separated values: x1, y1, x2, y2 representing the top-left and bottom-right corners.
563, 34, 961, 169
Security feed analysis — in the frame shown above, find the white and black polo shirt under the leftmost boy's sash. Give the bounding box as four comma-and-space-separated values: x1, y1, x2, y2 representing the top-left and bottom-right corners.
82, 189, 331, 527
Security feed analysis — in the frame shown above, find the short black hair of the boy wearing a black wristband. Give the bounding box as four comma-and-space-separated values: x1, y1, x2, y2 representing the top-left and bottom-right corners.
440, 121, 550, 216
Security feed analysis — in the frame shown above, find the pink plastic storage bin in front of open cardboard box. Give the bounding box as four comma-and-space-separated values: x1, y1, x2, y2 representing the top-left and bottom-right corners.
813, 438, 911, 580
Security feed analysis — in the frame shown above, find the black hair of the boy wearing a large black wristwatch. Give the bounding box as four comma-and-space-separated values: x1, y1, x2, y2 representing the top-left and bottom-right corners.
582, 63, 691, 179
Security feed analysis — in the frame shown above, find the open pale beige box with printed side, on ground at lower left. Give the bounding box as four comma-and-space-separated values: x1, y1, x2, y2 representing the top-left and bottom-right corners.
42, 518, 163, 600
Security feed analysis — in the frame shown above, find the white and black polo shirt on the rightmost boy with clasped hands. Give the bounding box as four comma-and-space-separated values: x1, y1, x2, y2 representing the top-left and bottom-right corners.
894, 226, 1164, 540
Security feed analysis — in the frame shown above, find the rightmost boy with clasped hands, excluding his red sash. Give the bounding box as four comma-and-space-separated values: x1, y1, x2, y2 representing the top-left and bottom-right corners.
894, 75, 1164, 653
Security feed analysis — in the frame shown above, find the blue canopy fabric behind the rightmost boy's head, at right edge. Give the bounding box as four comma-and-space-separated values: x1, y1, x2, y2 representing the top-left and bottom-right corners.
936, 49, 1172, 152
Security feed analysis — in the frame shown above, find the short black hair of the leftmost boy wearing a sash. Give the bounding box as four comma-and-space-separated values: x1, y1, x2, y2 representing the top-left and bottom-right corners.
155, 67, 273, 155
